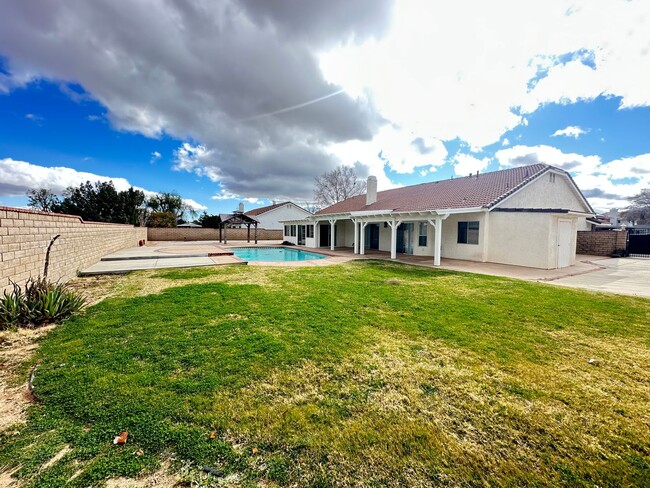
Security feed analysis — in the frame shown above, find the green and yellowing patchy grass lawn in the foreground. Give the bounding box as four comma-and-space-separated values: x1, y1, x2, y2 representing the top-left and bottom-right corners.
0, 261, 650, 486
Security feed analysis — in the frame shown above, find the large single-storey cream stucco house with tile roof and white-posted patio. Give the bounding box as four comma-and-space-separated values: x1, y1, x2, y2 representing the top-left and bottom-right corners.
284, 164, 594, 269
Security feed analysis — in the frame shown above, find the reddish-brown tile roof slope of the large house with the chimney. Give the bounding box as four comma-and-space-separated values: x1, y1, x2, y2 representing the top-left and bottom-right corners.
316, 164, 548, 215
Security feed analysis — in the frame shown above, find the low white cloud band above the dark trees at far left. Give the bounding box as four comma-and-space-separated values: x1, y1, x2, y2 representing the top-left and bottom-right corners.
0, 158, 207, 210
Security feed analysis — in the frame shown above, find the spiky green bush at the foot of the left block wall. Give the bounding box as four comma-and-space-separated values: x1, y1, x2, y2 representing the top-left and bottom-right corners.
0, 277, 86, 330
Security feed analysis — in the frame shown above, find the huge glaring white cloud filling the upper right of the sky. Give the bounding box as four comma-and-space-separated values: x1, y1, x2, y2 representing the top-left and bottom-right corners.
321, 0, 650, 148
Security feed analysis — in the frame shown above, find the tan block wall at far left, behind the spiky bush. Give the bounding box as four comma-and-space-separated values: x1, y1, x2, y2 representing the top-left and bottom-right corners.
0, 207, 147, 291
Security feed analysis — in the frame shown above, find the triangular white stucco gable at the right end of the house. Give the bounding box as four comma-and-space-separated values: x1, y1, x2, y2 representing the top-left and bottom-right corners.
497, 172, 589, 212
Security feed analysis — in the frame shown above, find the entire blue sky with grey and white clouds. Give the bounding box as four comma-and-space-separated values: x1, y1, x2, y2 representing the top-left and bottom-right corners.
0, 0, 650, 213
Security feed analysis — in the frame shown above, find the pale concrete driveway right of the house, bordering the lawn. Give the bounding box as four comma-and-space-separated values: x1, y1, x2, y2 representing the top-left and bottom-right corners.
549, 258, 650, 298
